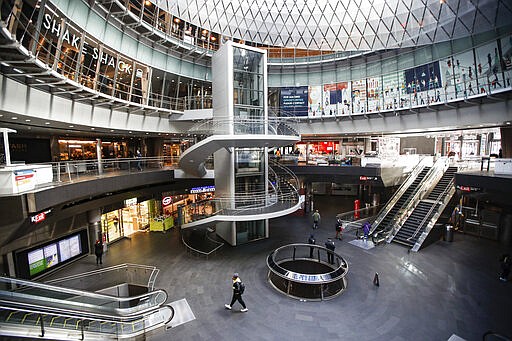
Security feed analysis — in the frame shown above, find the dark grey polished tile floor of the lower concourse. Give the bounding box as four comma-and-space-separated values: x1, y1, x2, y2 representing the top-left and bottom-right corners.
46, 196, 512, 341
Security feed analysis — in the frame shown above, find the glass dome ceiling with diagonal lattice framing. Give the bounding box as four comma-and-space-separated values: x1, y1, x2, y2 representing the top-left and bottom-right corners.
155, 0, 512, 51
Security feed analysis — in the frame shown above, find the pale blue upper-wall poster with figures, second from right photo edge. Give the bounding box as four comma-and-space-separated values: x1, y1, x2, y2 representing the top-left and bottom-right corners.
475, 43, 503, 93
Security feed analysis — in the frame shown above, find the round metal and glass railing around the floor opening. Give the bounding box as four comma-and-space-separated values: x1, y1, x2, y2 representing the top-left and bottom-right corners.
267, 244, 348, 301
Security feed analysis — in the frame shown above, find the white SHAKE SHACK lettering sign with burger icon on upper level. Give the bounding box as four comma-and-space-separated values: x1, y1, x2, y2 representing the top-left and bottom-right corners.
43, 13, 143, 78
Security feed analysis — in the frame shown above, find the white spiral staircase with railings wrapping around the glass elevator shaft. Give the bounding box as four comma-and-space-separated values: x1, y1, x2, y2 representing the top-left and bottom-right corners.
179, 117, 300, 228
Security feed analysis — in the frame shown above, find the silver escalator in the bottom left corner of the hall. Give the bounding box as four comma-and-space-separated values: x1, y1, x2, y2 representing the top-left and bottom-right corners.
0, 277, 174, 340
